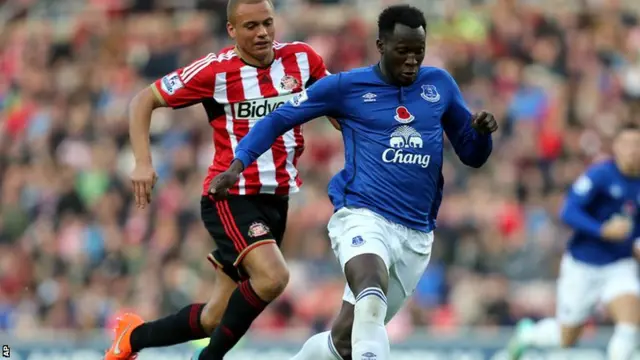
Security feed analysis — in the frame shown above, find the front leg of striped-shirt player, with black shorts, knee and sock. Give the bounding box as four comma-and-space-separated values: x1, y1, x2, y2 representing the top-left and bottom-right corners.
199, 196, 289, 360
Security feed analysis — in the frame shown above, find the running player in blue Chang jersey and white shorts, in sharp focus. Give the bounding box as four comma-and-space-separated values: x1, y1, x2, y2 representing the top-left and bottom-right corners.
211, 5, 498, 360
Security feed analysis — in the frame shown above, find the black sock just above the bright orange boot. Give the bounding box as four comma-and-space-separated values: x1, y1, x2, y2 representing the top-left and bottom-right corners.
131, 304, 209, 352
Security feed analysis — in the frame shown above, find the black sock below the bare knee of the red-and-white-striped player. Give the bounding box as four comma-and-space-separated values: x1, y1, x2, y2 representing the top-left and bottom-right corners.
198, 280, 269, 360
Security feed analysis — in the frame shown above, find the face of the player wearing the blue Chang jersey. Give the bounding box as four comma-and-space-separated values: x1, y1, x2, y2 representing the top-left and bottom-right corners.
378, 24, 427, 86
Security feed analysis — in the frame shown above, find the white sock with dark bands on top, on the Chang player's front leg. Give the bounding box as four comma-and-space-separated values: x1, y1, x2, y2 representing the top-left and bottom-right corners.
351, 287, 391, 360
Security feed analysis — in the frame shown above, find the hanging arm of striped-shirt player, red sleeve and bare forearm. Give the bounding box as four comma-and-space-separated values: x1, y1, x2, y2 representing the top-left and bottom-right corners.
129, 54, 215, 208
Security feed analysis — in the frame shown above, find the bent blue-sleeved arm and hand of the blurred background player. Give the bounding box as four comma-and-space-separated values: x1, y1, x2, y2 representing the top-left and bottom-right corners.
560, 166, 631, 241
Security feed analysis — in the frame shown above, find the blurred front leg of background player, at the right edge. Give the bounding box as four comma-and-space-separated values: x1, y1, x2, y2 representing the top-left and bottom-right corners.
602, 259, 640, 360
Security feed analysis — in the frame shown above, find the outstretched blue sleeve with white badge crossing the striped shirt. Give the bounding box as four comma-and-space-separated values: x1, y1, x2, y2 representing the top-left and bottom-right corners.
232, 74, 341, 169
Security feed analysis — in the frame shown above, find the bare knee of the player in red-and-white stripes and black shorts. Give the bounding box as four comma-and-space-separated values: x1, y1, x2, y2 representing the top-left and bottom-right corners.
242, 243, 289, 301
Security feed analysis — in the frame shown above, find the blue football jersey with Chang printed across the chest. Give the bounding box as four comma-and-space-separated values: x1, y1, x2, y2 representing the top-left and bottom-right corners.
236, 65, 492, 231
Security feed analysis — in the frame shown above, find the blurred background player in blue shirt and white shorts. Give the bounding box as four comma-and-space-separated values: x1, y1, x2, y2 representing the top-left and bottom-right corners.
509, 125, 640, 360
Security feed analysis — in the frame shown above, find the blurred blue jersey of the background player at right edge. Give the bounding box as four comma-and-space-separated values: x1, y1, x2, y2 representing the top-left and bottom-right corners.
560, 161, 640, 265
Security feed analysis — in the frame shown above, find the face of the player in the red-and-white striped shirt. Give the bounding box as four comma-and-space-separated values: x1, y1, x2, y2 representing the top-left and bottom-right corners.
227, 0, 276, 60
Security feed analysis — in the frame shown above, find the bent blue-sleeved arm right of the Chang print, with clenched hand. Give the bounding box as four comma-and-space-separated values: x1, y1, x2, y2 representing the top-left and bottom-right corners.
442, 74, 498, 168
